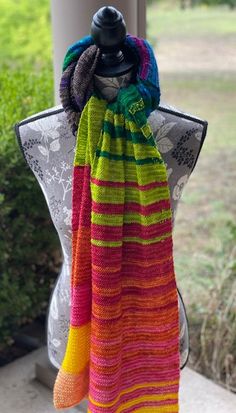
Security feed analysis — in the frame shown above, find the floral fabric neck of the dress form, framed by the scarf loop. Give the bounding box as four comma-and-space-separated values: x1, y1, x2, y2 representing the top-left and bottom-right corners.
94, 70, 132, 102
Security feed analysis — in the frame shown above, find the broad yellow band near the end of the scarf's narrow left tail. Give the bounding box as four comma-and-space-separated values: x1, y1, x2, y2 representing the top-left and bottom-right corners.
62, 322, 91, 374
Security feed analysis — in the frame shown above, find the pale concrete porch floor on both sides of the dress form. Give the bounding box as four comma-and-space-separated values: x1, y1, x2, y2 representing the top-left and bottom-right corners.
0, 347, 236, 413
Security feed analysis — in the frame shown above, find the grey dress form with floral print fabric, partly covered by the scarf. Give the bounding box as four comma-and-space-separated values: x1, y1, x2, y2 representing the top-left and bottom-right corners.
16, 6, 207, 378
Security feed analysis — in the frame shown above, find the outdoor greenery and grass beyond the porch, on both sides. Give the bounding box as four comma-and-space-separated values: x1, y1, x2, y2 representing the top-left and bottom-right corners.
0, 0, 236, 392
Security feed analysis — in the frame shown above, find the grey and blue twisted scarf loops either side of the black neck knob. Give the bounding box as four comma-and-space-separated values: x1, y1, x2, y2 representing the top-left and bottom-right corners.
60, 35, 160, 135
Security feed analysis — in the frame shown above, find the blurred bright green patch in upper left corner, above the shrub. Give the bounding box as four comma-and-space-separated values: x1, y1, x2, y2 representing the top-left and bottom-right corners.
0, 0, 52, 67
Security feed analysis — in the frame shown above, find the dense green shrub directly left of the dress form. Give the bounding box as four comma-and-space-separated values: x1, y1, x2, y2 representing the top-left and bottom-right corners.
0, 65, 60, 348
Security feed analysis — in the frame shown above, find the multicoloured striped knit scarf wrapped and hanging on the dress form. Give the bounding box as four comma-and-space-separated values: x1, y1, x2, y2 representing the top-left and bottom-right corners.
53, 35, 180, 413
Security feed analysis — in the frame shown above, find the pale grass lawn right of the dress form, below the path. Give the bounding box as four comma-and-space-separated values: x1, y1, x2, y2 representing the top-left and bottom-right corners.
162, 69, 236, 312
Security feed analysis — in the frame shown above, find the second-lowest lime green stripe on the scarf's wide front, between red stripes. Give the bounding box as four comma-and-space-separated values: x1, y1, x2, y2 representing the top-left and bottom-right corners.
92, 210, 171, 227
